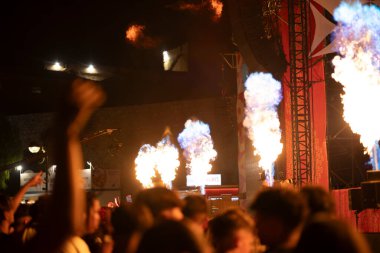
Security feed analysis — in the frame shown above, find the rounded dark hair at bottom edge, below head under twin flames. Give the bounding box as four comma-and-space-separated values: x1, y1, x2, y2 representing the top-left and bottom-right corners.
137, 220, 204, 253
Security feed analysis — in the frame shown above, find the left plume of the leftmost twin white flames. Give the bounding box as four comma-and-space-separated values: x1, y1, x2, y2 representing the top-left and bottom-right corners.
135, 144, 156, 188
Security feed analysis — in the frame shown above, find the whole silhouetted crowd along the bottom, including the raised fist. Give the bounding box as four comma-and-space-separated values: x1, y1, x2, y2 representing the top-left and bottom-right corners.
0, 80, 370, 253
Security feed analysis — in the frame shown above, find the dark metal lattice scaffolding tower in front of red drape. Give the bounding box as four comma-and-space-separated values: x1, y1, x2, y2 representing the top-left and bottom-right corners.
288, 0, 313, 187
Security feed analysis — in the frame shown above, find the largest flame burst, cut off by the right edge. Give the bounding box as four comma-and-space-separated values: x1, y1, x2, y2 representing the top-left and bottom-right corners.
332, 2, 380, 166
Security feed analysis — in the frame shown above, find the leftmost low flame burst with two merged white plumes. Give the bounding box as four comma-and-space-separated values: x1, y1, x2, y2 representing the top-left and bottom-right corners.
135, 135, 179, 189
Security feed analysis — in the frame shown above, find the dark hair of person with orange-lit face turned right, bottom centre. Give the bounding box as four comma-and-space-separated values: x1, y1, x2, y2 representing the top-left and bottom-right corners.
208, 208, 253, 253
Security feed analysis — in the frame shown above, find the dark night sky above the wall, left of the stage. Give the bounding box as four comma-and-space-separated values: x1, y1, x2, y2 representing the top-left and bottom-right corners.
0, 0, 236, 114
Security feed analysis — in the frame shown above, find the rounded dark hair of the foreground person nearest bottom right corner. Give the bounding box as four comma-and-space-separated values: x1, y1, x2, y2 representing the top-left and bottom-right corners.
294, 215, 370, 253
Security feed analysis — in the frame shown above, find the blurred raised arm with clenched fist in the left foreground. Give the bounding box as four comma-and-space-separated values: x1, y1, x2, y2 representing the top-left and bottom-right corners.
35, 80, 105, 250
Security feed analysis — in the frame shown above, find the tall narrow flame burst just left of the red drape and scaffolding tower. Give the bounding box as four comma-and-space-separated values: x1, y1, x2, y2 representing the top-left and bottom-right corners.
243, 73, 282, 185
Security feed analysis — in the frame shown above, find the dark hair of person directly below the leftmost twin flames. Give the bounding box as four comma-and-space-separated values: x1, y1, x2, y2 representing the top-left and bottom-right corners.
134, 187, 182, 218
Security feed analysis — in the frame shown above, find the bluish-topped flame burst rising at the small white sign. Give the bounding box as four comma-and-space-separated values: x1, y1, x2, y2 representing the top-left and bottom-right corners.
178, 120, 217, 194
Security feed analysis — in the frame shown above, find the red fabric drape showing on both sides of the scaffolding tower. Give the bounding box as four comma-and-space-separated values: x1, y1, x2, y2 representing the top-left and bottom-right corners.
279, 1, 329, 189
